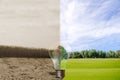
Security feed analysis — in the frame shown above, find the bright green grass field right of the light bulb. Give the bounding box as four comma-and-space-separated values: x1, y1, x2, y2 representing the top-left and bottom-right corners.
61, 59, 120, 80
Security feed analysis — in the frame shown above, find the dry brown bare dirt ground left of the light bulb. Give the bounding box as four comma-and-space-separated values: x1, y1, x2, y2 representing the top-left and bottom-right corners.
0, 58, 56, 80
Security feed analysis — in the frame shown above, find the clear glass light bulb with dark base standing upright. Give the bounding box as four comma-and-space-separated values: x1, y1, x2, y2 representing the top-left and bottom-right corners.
49, 46, 68, 79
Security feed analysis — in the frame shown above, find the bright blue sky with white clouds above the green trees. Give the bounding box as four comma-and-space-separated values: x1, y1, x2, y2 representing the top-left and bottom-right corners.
60, 0, 120, 51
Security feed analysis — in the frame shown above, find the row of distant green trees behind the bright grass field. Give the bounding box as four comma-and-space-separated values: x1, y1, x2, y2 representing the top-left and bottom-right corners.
70, 49, 120, 58
